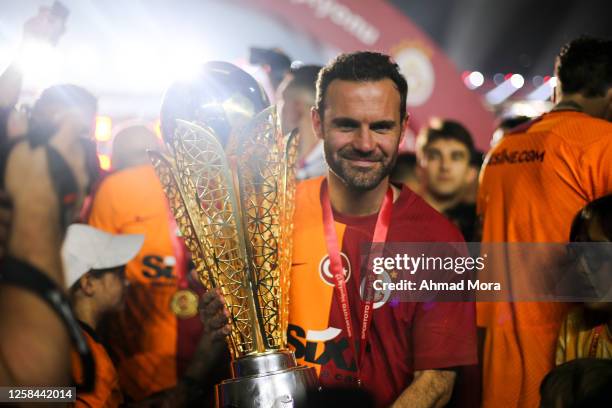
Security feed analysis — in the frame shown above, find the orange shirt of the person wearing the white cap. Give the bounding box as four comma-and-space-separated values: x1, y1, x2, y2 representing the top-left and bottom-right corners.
72, 323, 123, 408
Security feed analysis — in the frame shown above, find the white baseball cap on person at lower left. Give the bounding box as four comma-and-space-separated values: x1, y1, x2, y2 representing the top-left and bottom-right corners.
62, 224, 144, 288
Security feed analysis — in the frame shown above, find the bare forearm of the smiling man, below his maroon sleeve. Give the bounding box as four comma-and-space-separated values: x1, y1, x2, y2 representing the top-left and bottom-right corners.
392, 370, 456, 408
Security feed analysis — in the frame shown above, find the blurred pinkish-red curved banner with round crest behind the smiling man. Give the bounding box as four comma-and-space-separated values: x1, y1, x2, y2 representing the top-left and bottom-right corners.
243, 0, 494, 151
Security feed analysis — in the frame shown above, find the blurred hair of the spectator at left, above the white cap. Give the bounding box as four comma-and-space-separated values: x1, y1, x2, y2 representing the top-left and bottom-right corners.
34, 84, 98, 112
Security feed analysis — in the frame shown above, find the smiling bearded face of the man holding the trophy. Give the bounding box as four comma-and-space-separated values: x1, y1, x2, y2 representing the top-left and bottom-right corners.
312, 79, 407, 190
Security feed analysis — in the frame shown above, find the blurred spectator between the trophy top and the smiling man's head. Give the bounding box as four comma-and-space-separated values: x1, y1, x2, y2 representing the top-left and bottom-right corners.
276, 65, 327, 180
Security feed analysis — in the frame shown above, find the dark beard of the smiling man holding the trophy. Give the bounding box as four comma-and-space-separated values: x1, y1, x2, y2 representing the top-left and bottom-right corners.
323, 143, 397, 191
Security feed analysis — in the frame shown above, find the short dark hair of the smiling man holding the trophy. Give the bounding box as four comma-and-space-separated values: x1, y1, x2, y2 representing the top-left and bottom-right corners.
316, 51, 408, 120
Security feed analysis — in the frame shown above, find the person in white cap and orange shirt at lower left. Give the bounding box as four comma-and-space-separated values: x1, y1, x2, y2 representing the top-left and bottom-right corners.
62, 224, 144, 408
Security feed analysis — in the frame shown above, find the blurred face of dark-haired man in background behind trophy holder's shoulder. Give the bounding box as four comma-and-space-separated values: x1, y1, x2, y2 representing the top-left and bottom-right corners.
421, 139, 473, 198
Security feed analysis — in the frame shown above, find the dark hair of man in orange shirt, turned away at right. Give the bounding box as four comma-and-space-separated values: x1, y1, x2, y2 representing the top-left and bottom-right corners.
555, 37, 612, 97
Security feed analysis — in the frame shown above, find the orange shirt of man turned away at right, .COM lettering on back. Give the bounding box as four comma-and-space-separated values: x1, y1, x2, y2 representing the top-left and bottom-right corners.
477, 111, 612, 407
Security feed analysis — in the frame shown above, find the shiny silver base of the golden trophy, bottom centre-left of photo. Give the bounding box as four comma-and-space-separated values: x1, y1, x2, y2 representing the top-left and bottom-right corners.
216, 351, 318, 408
